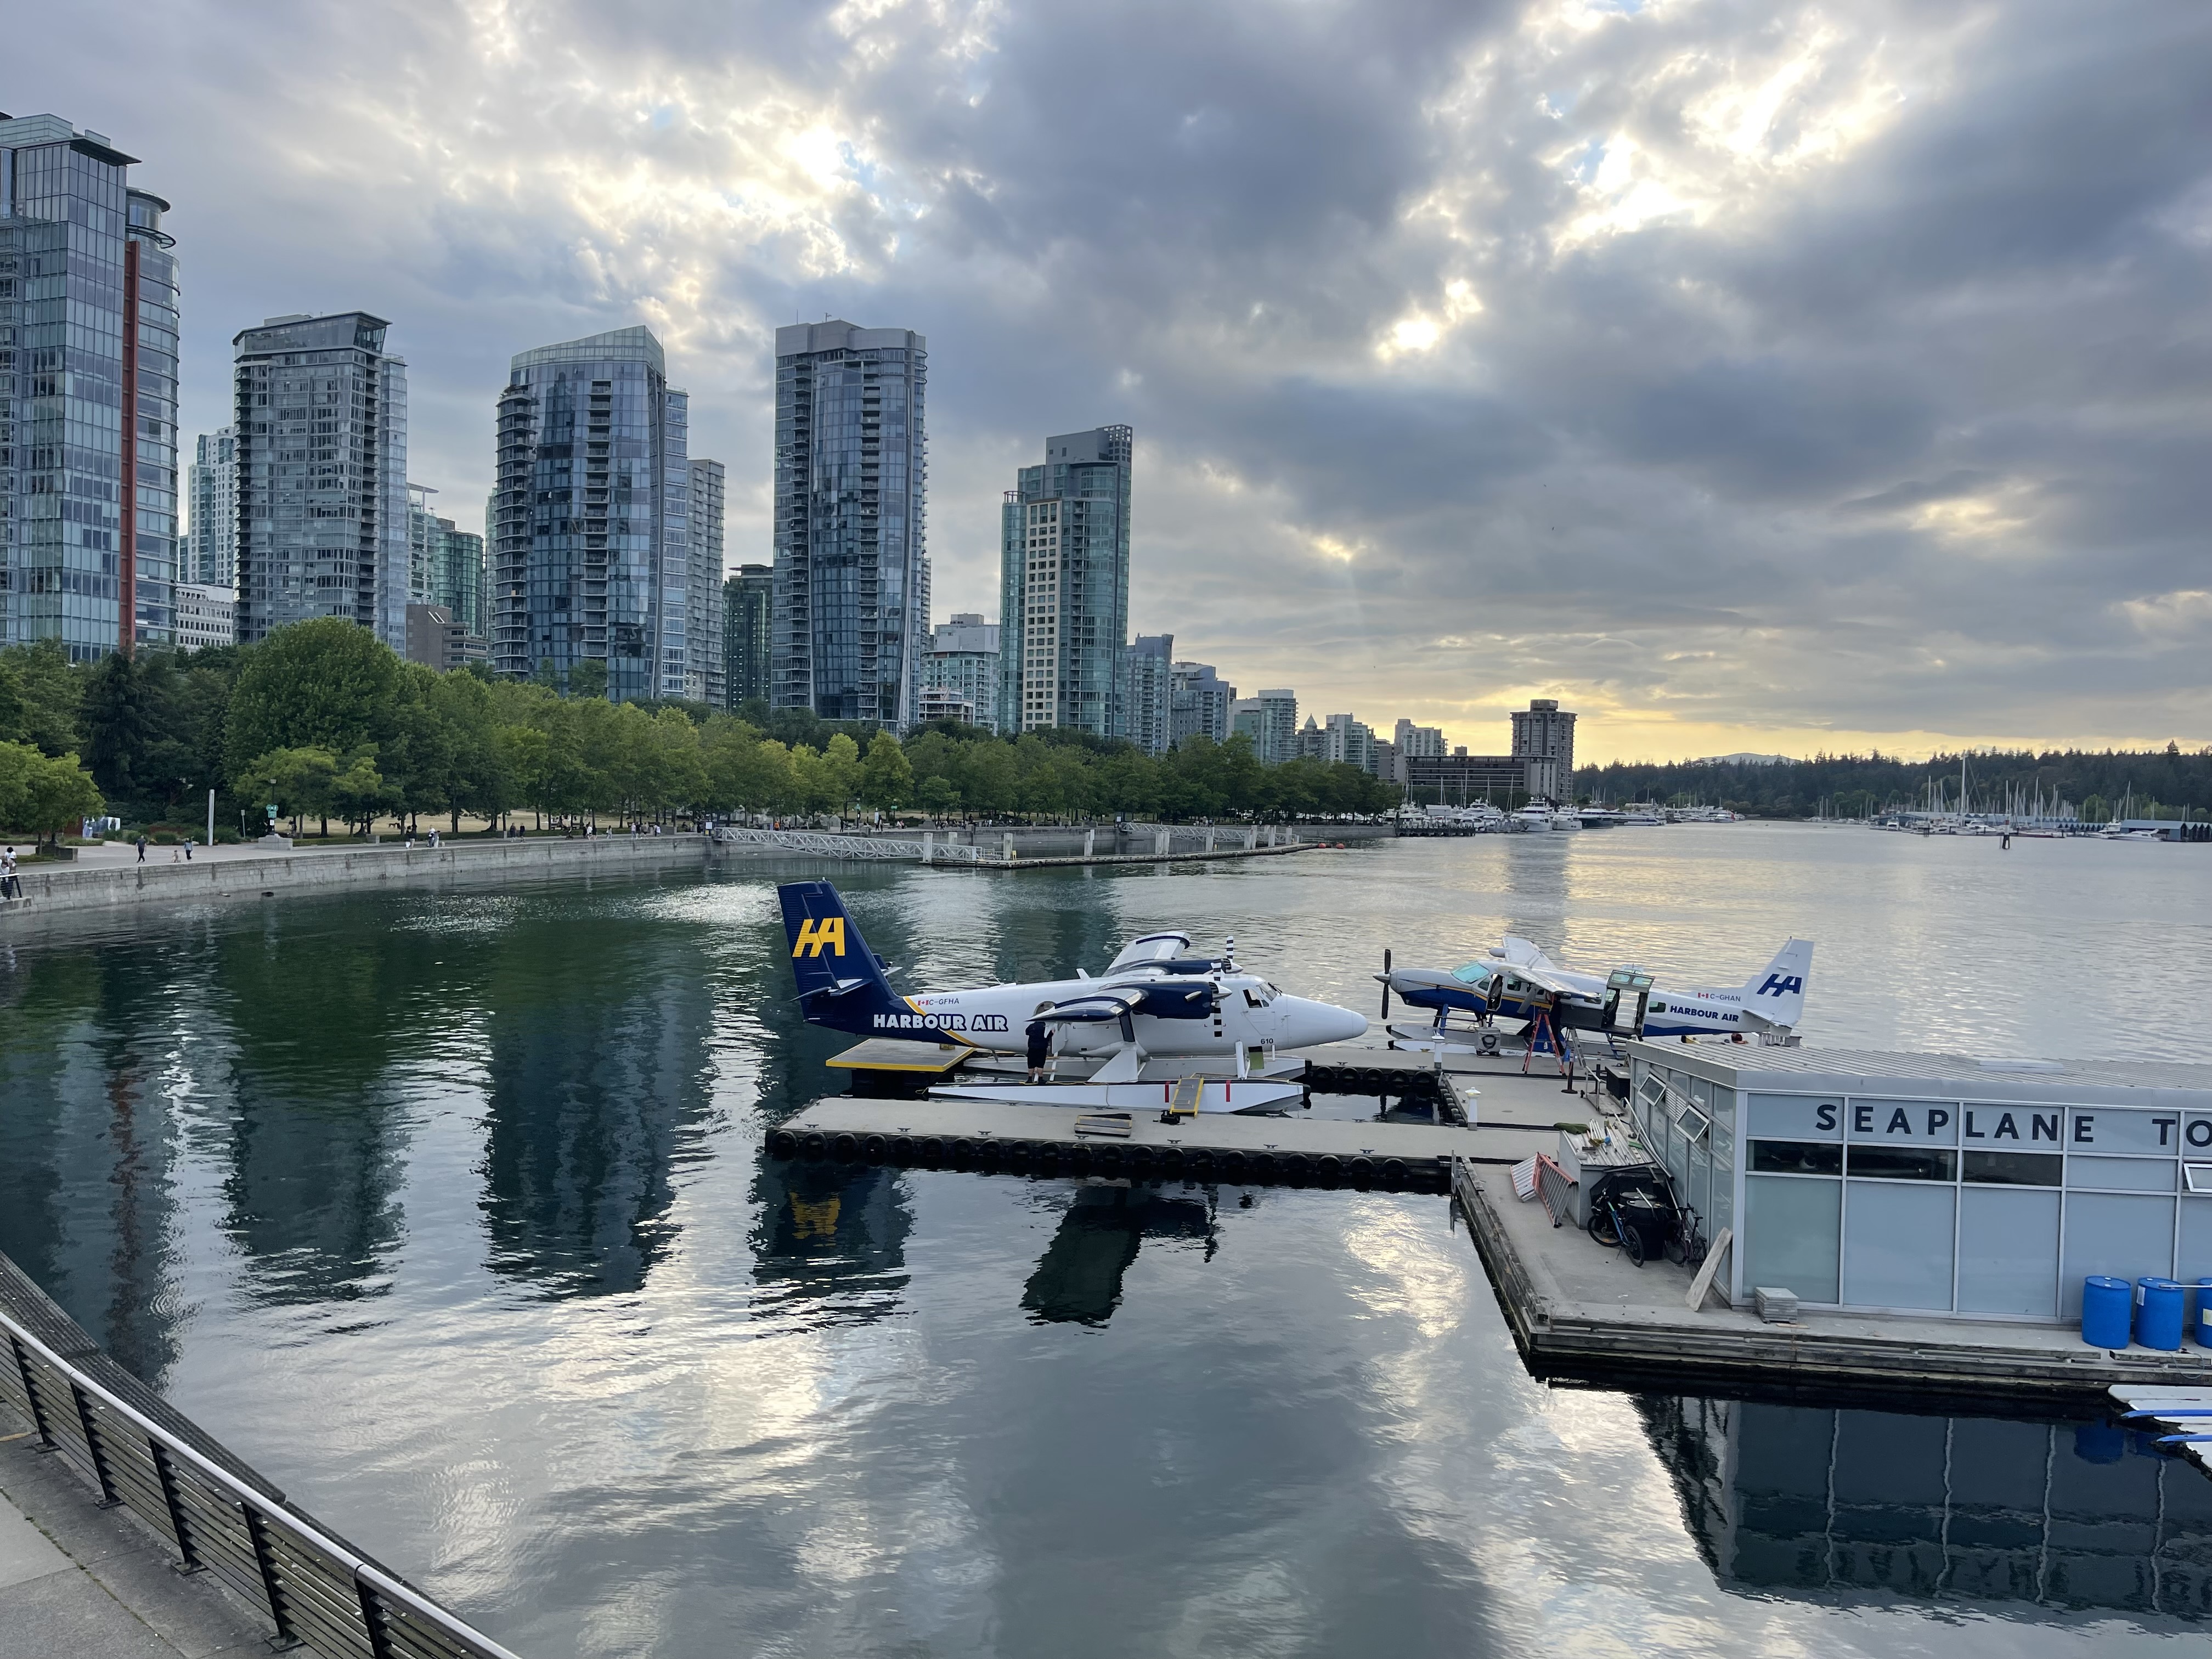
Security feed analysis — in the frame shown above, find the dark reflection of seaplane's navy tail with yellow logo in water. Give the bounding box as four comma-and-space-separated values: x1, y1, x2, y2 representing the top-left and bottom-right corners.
752, 1159, 913, 1323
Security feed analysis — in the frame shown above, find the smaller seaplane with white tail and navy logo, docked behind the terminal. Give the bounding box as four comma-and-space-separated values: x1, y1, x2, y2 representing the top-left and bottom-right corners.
1376, 934, 1812, 1046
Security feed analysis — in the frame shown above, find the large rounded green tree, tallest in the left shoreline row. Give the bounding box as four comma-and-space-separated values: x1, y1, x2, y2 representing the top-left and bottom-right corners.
225, 617, 400, 774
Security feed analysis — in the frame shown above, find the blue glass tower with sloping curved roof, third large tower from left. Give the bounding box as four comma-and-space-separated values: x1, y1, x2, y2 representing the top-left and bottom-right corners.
487, 328, 685, 701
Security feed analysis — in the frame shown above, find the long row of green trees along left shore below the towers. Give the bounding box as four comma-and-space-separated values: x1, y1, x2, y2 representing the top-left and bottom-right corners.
0, 617, 1398, 838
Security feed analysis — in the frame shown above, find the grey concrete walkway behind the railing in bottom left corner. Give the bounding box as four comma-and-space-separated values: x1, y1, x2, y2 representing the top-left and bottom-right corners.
0, 1418, 270, 1659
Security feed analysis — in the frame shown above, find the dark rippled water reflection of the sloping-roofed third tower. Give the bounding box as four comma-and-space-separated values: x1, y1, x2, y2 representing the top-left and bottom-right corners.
484, 955, 714, 1296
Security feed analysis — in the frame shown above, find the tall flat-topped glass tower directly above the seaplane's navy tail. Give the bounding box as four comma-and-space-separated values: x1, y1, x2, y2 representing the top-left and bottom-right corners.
770, 321, 929, 725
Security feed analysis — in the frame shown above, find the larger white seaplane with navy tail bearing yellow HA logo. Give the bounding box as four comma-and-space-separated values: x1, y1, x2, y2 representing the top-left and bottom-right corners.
776, 881, 1367, 1113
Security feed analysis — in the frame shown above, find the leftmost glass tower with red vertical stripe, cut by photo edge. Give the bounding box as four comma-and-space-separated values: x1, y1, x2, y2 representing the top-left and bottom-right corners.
0, 115, 177, 662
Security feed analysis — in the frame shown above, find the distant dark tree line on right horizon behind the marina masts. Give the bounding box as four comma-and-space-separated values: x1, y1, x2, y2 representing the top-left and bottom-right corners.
1575, 743, 2212, 823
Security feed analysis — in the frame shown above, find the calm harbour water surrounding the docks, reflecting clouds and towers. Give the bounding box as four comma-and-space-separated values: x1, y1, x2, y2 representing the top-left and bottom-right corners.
0, 825, 2212, 1659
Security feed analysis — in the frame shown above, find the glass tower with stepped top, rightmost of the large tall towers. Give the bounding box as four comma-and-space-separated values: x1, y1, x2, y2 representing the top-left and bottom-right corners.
997, 427, 1166, 737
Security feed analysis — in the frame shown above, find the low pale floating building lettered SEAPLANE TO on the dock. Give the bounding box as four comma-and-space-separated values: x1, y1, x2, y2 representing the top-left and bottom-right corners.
1630, 1053, 2212, 1323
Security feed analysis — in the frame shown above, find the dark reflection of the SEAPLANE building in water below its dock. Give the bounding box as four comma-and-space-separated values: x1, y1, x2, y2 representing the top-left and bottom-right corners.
1637, 1396, 2212, 1617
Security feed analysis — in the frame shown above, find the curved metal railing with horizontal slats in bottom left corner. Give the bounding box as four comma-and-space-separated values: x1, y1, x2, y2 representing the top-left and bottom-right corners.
0, 1307, 515, 1659
